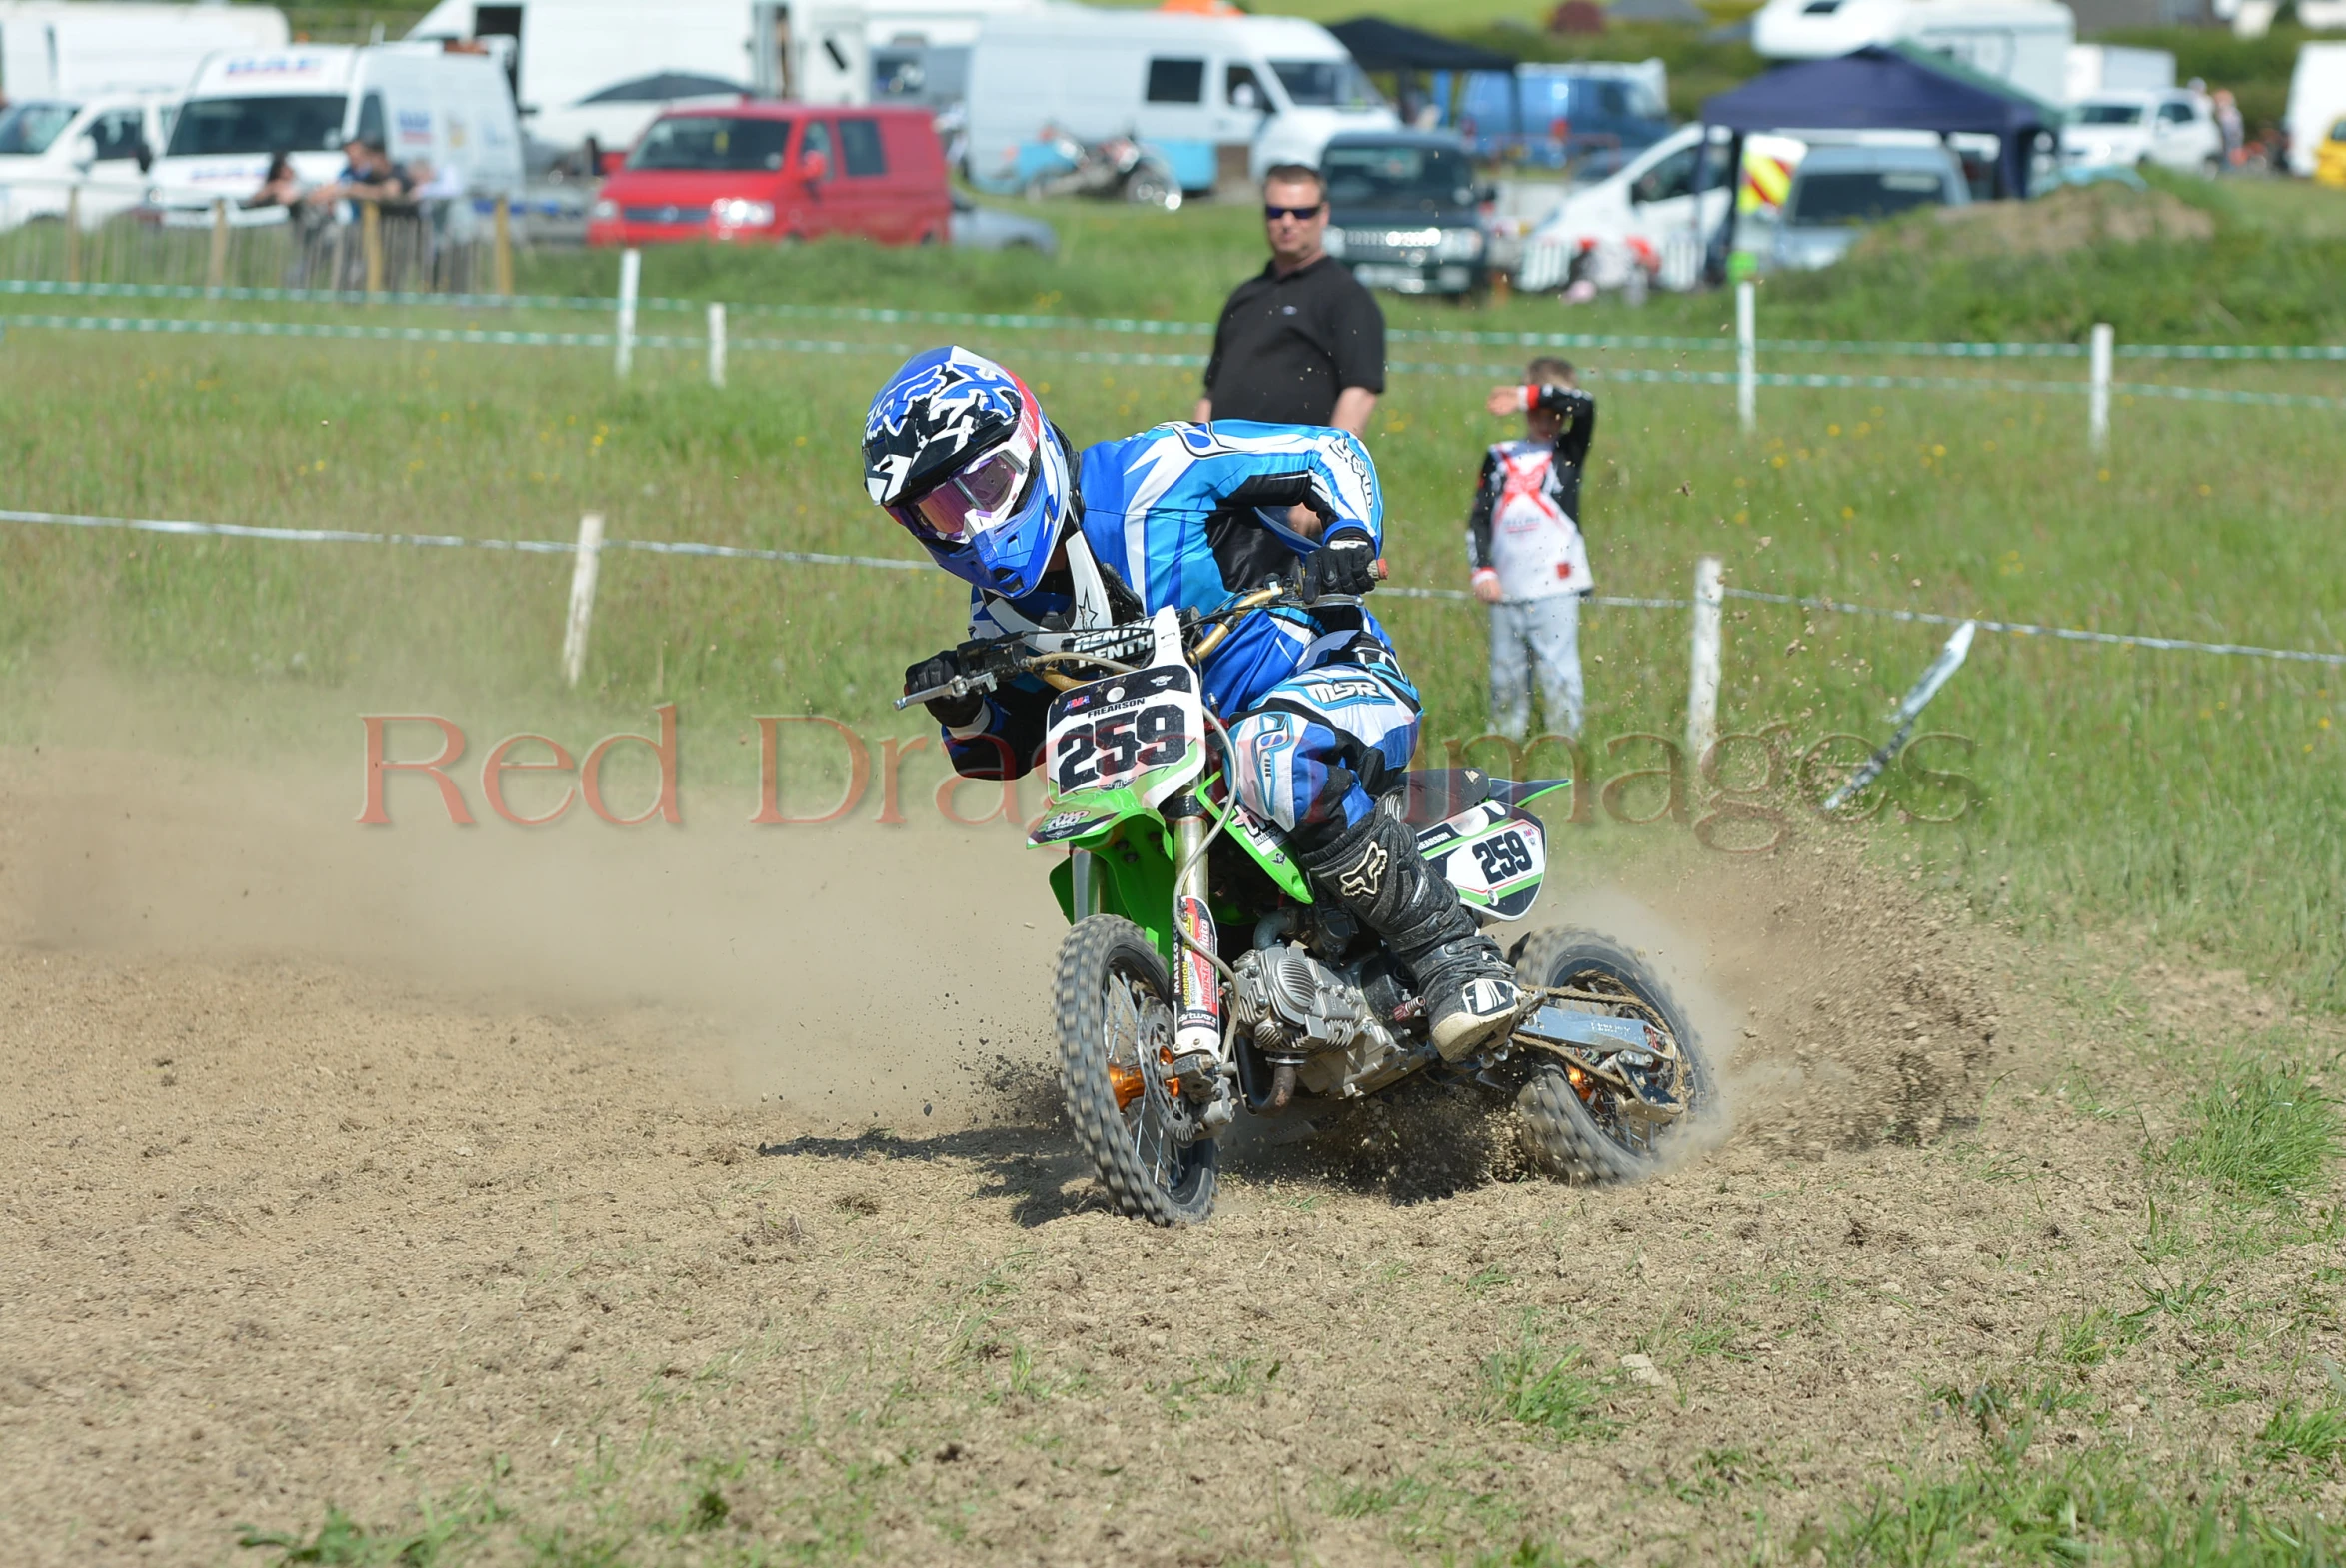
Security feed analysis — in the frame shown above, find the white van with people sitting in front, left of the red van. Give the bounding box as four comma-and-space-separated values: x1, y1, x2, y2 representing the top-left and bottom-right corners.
153, 45, 521, 206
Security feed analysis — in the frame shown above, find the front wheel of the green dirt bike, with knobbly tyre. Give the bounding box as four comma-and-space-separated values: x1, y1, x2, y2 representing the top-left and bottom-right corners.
1054, 914, 1219, 1226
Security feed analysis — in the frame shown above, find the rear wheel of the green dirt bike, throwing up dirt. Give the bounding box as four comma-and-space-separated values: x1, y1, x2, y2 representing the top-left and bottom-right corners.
1515, 930, 1715, 1186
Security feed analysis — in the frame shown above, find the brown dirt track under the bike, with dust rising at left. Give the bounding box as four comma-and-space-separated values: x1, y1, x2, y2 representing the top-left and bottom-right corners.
0, 758, 2346, 1563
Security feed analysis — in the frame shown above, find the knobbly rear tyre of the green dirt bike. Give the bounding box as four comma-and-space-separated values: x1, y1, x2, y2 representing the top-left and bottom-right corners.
1515, 928, 1717, 1186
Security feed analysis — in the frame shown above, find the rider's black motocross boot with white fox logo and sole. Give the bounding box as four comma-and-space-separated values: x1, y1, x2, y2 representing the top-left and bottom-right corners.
1288, 810, 1525, 1061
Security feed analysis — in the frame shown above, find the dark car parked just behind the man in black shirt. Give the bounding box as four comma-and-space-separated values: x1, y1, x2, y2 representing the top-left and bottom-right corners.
1320, 131, 1494, 293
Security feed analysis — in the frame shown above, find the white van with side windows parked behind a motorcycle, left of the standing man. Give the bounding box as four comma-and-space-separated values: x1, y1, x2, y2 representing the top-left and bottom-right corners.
969, 5, 1400, 190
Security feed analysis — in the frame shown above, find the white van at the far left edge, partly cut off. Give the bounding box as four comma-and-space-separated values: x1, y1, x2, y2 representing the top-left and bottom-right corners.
0, 94, 176, 230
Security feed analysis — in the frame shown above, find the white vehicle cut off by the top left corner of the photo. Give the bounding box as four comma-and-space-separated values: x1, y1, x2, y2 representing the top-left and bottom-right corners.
0, 0, 289, 103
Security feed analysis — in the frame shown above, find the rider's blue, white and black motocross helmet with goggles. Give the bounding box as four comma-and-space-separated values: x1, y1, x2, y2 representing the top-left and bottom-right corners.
864, 347, 1075, 598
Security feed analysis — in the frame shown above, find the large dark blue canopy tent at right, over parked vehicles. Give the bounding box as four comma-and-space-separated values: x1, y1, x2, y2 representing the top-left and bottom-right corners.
1703, 45, 2060, 277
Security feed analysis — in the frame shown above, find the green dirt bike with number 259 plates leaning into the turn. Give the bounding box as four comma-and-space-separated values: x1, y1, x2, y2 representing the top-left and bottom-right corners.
897, 584, 1710, 1226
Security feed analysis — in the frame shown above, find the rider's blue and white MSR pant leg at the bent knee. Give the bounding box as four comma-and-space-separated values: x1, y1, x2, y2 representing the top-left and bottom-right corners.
1229, 664, 1419, 839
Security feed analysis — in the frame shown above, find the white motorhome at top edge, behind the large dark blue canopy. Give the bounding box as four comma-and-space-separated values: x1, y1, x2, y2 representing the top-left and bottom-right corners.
1752, 0, 2076, 103
